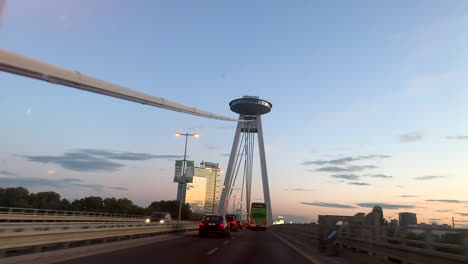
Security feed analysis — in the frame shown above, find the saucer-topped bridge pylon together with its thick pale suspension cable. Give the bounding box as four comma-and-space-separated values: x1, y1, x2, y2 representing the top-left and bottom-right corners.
0, 49, 272, 224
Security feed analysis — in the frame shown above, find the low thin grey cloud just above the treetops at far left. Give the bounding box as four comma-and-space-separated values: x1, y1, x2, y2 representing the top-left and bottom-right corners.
0, 177, 127, 192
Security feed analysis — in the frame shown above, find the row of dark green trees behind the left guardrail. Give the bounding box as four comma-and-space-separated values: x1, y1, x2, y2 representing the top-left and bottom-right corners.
0, 187, 194, 219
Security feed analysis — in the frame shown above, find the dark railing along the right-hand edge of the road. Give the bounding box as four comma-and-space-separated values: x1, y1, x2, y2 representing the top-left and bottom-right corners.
274, 224, 468, 263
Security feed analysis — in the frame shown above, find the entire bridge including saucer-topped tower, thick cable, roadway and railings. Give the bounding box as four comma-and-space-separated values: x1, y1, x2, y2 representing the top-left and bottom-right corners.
0, 50, 468, 264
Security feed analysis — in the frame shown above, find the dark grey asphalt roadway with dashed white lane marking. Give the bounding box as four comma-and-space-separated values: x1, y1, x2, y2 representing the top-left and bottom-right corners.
57, 230, 311, 264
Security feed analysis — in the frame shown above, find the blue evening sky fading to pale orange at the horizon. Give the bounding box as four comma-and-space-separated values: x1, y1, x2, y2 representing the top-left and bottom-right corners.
0, 0, 468, 227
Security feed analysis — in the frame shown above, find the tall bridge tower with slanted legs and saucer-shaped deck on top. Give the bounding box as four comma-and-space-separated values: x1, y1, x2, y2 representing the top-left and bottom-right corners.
218, 96, 273, 225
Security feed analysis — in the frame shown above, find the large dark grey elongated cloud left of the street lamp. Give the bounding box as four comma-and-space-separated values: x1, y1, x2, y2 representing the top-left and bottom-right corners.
23, 149, 182, 172
